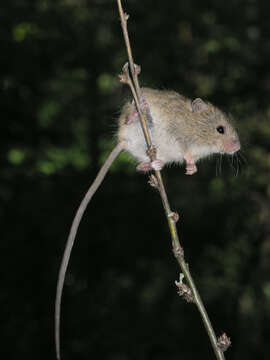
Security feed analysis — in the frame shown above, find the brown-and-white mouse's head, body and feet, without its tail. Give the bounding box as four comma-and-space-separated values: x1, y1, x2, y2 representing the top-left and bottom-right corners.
118, 88, 240, 175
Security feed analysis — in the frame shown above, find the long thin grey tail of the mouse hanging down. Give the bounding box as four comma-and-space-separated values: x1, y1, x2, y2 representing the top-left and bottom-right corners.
55, 143, 124, 360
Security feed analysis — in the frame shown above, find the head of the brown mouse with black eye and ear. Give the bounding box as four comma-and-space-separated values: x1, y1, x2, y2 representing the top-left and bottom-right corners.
191, 98, 240, 155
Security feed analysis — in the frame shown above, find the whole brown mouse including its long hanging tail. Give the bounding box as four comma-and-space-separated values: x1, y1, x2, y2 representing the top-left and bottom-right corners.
55, 88, 240, 359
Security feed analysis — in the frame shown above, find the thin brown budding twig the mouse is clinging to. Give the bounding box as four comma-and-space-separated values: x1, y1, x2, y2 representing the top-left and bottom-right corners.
117, 0, 228, 360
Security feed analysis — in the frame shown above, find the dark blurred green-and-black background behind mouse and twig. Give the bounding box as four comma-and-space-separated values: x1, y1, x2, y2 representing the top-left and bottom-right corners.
0, 0, 270, 360
